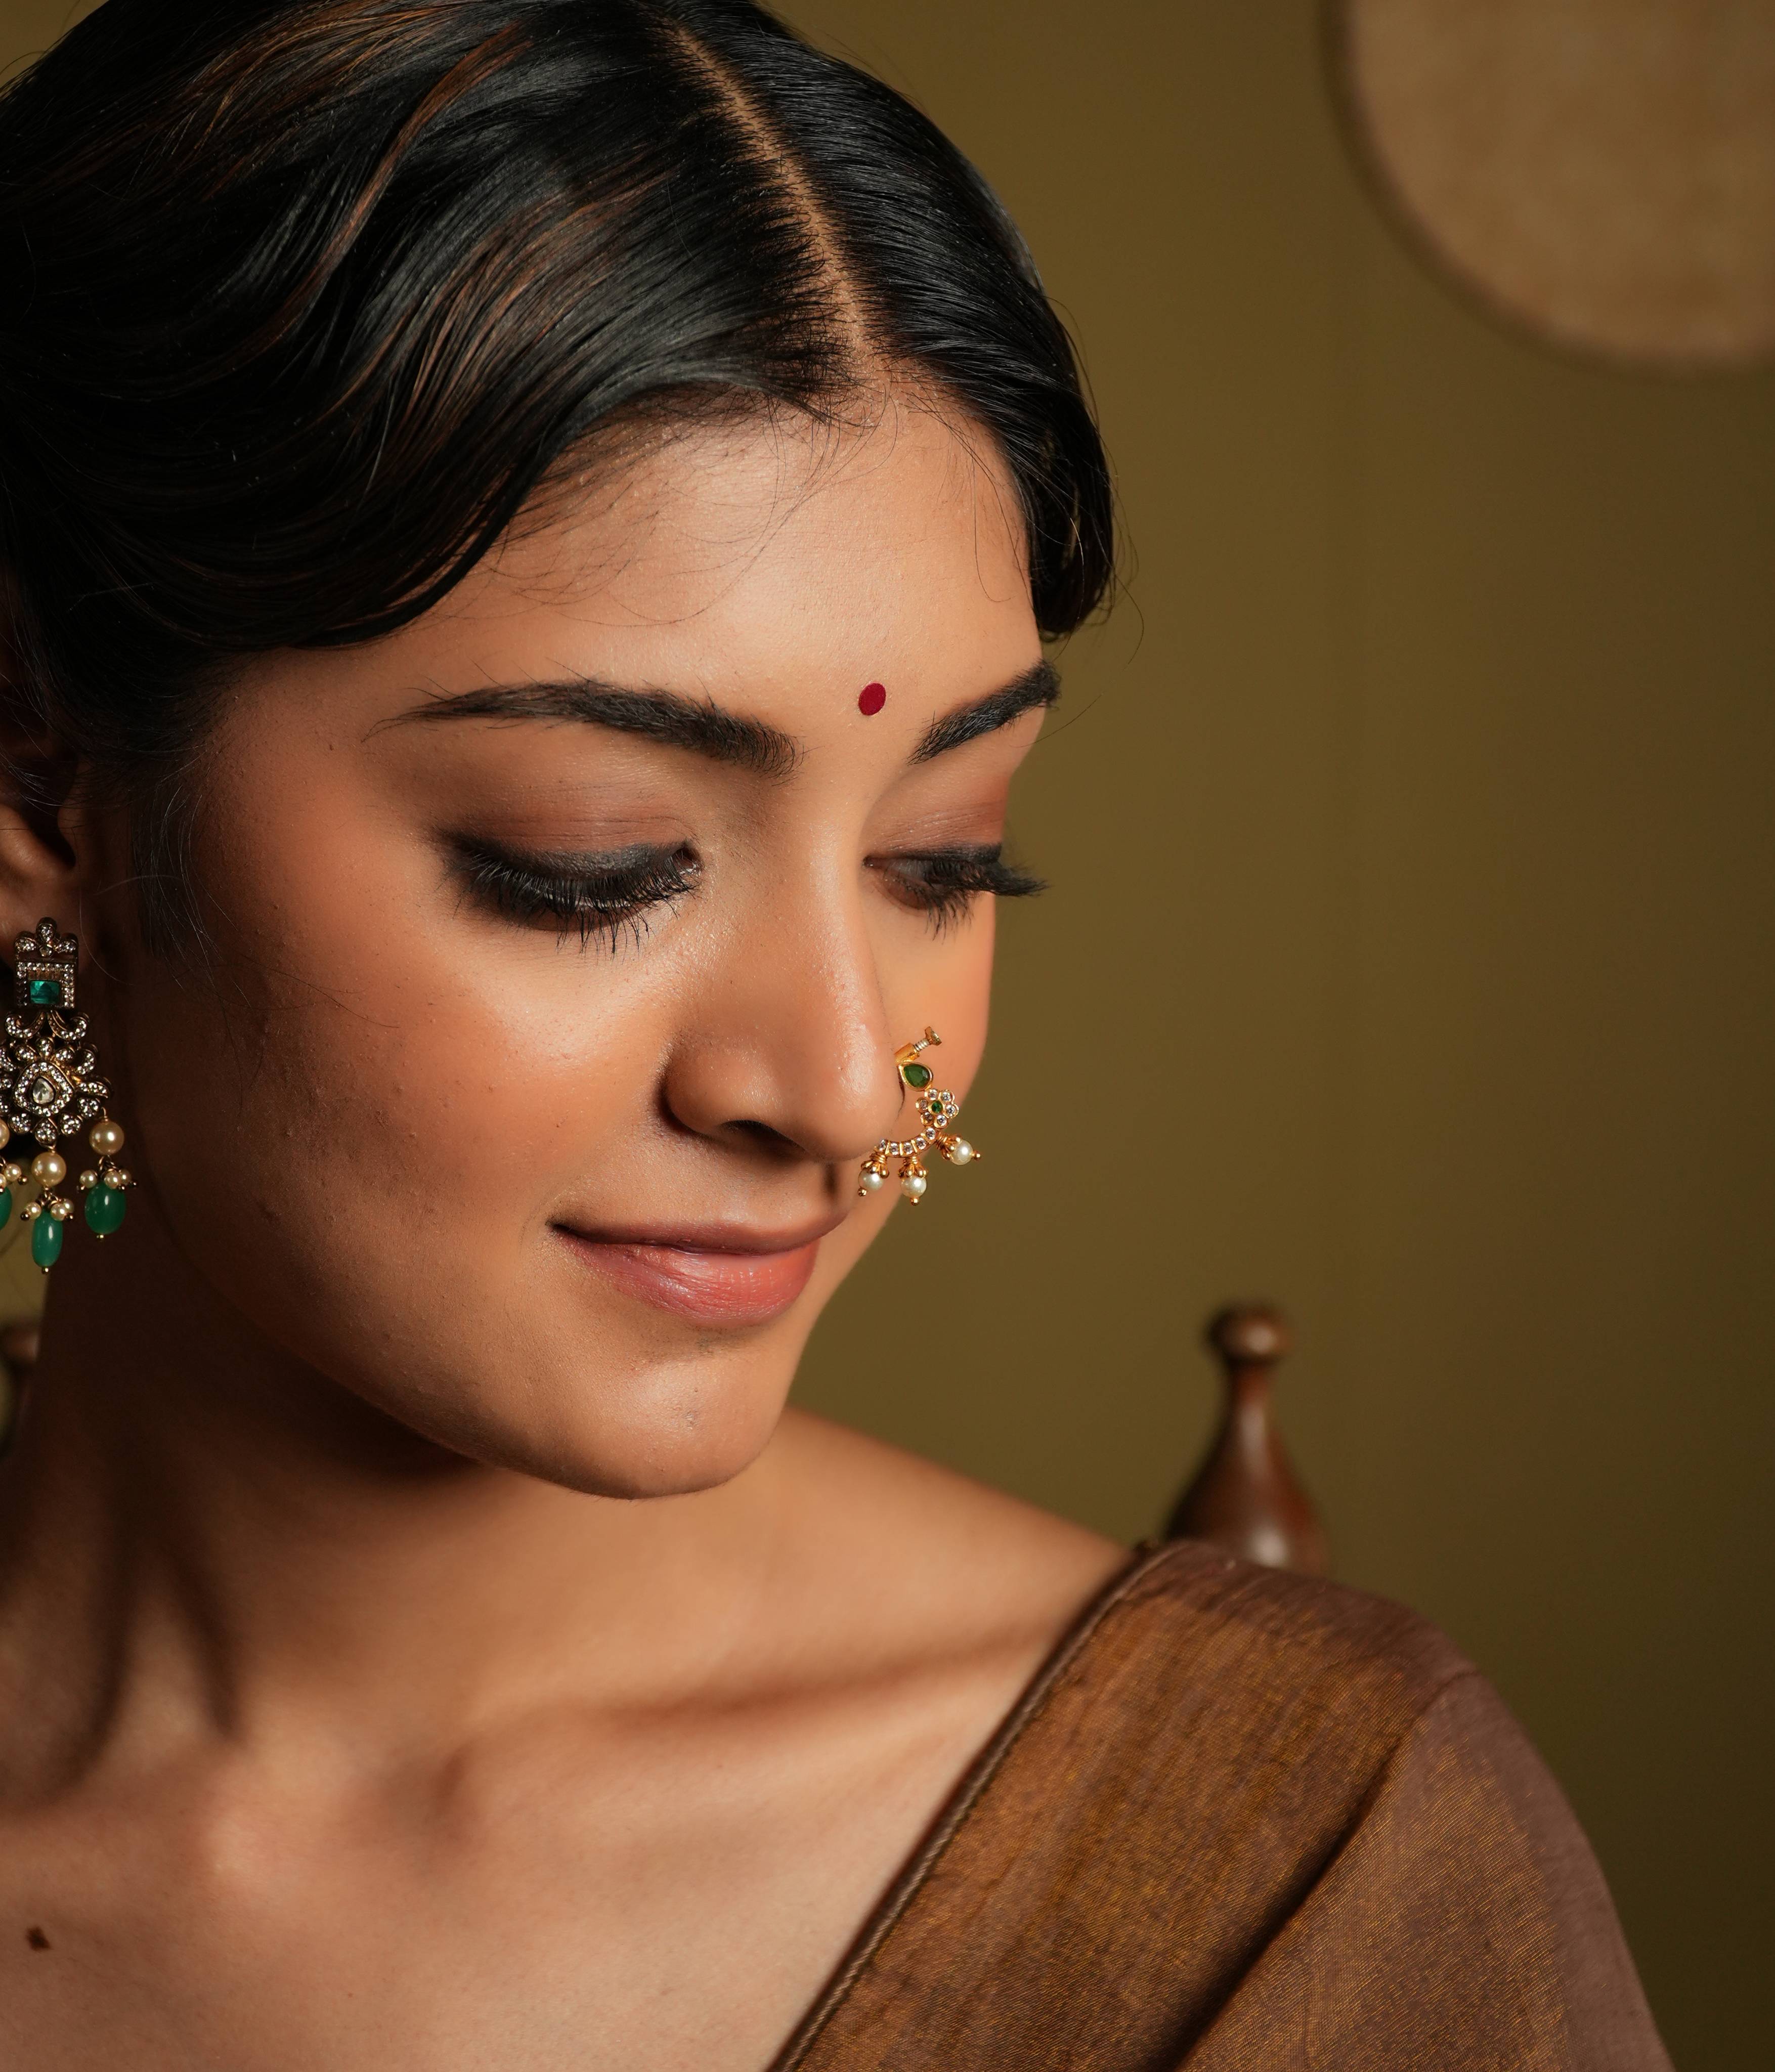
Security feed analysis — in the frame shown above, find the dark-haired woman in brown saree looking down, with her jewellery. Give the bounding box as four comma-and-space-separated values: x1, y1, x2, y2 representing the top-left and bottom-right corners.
0, 0, 1663, 2072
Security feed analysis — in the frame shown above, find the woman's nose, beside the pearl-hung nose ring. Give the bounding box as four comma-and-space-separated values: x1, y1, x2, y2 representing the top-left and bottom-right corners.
665, 874, 901, 1164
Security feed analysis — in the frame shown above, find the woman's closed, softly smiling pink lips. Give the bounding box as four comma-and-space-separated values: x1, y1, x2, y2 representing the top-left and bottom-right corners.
555, 1218, 843, 1328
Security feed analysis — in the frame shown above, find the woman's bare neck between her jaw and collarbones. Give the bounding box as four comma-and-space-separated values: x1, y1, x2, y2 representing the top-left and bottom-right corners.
0, 1218, 779, 1788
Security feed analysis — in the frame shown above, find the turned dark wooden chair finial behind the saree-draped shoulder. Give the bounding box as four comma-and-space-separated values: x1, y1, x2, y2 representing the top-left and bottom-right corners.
1164, 1303, 1330, 1575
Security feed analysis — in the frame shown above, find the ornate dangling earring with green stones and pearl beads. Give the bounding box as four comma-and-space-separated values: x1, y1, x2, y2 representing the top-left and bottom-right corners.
0, 918, 131, 1272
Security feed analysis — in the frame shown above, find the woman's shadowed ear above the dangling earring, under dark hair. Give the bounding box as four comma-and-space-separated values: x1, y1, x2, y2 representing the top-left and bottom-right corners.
0, 570, 89, 945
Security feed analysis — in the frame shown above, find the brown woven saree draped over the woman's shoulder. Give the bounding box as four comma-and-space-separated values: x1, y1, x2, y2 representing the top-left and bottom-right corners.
772, 1544, 1669, 2072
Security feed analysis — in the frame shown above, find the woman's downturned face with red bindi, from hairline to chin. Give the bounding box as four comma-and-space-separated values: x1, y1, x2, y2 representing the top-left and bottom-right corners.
90, 408, 1048, 1494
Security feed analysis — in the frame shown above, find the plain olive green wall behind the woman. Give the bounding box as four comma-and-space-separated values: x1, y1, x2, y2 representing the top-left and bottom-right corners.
0, 0, 1775, 2072
